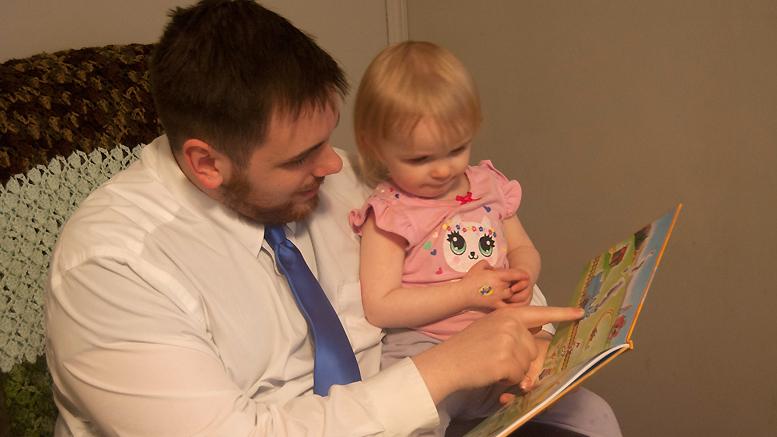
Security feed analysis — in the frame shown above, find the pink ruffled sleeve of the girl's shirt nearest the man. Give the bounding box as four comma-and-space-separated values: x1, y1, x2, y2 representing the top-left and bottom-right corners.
349, 184, 417, 243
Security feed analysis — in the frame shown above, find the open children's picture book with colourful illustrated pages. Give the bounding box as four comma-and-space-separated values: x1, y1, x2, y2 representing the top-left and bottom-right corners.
465, 205, 681, 437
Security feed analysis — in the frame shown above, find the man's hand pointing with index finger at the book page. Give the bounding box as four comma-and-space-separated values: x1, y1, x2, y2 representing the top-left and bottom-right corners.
413, 306, 583, 404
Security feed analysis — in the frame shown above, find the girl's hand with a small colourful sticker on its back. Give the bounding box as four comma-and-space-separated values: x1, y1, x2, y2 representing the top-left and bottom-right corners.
461, 260, 532, 311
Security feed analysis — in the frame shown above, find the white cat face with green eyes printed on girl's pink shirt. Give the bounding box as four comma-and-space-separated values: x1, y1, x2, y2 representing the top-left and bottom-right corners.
442, 214, 499, 272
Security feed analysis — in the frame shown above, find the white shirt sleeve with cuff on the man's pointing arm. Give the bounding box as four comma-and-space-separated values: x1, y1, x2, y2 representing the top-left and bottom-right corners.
46, 257, 438, 436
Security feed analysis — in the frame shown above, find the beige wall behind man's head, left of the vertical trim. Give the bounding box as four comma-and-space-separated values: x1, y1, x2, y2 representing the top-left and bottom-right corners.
0, 0, 388, 151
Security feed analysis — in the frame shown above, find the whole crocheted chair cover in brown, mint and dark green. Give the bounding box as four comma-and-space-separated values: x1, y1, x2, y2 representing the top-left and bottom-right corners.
0, 44, 162, 437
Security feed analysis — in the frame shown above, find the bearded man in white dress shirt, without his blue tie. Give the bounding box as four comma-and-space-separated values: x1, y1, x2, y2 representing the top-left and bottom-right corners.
46, 0, 620, 436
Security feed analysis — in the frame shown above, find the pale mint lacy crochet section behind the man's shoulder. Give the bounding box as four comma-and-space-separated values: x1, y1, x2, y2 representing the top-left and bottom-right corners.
0, 146, 143, 372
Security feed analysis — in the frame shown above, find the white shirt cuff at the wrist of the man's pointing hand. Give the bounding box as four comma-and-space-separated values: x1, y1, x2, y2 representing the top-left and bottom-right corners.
364, 358, 440, 437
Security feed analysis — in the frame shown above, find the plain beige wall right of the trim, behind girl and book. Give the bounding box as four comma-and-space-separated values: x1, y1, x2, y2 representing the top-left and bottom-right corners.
408, 0, 777, 437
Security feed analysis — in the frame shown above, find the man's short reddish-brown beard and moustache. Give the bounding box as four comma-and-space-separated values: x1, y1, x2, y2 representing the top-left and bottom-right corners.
221, 170, 324, 224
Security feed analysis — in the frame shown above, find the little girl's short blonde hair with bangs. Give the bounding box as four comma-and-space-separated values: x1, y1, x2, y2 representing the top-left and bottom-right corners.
353, 41, 483, 186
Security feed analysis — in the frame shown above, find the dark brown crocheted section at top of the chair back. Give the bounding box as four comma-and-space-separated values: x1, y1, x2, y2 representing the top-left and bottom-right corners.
0, 44, 162, 184
